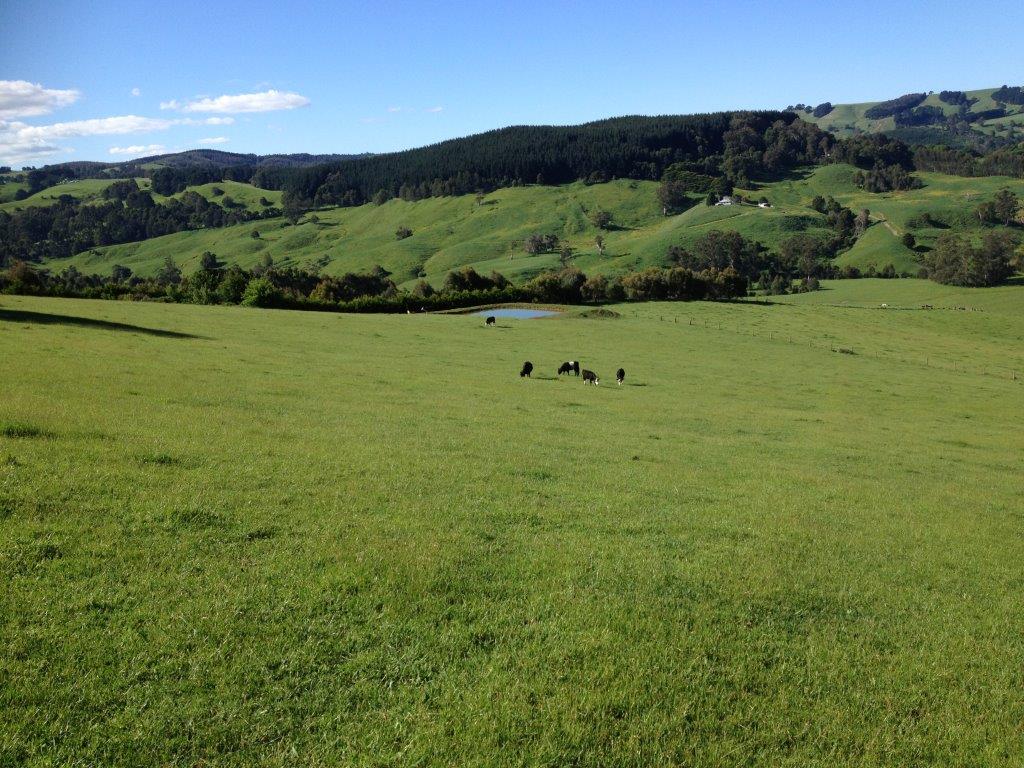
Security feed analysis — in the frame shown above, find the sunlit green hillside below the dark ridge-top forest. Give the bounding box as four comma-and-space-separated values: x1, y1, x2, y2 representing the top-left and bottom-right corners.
44, 165, 1024, 286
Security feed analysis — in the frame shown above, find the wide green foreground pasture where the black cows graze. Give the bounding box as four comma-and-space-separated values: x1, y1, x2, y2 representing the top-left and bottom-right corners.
0, 280, 1024, 766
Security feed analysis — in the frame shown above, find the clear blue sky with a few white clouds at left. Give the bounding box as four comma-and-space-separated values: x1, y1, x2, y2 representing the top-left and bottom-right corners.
0, 0, 1024, 167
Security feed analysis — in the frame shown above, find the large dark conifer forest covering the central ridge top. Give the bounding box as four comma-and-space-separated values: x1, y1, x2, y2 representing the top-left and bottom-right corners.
252, 112, 834, 214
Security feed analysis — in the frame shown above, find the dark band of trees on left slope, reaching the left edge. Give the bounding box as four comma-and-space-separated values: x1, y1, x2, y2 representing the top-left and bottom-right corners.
0, 190, 281, 265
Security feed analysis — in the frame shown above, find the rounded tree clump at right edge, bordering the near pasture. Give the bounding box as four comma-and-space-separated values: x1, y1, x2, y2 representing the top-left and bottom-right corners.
924, 231, 1015, 287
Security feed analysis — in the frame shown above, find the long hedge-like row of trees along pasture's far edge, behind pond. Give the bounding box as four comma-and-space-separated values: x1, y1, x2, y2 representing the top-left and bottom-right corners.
0, 259, 748, 312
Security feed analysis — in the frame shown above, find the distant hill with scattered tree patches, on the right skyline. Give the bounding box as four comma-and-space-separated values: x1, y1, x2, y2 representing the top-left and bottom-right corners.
788, 86, 1024, 148
